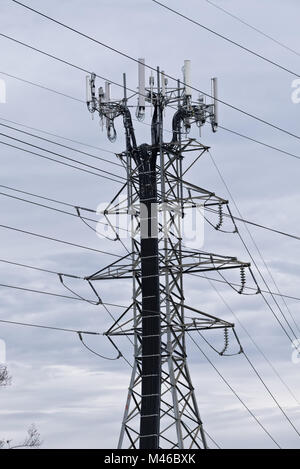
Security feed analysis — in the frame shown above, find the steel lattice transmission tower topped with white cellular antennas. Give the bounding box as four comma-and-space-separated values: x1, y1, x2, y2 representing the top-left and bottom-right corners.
87, 59, 254, 449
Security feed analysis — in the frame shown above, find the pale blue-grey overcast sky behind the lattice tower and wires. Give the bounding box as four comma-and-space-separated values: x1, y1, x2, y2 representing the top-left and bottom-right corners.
0, 0, 300, 448
